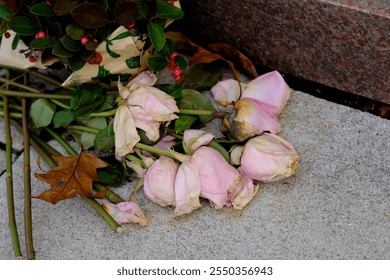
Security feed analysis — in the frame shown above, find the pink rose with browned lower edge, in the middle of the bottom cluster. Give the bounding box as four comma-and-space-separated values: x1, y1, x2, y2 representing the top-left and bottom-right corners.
191, 146, 241, 209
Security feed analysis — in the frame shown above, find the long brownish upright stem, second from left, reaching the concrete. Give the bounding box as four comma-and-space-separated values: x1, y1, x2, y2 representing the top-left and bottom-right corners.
22, 98, 35, 260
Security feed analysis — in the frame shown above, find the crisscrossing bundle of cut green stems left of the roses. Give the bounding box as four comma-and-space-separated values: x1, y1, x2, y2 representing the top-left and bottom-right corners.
0, 67, 124, 259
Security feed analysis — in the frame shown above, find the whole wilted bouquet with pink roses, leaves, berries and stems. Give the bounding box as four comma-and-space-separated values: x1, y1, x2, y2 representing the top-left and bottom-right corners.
0, 0, 299, 258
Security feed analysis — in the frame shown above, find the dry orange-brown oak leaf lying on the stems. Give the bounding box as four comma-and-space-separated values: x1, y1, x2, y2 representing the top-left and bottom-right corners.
33, 153, 108, 204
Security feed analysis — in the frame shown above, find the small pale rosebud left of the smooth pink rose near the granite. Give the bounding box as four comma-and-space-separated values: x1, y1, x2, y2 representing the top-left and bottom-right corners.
211, 79, 246, 106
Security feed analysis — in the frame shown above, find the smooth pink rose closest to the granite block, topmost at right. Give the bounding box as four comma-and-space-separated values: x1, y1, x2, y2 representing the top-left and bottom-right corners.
241, 71, 291, 115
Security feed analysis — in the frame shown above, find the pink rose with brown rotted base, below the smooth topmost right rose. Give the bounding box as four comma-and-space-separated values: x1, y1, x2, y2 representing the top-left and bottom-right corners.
232, 98, 281, 140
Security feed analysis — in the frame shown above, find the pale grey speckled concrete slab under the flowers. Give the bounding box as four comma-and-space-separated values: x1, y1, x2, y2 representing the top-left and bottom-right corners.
0, 89, 390, 259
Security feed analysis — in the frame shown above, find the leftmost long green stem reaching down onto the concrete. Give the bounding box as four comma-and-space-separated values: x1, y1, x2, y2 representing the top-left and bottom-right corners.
3, 80, 22, 258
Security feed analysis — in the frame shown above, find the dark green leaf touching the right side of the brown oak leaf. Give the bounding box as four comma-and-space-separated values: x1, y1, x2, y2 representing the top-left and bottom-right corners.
96, 156, 127, 186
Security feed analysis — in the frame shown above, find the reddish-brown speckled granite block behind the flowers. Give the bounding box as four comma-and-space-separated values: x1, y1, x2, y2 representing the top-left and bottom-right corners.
178, 0, 390, 103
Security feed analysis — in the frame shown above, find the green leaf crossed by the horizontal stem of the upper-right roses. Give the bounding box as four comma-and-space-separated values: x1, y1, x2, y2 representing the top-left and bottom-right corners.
177, 89, 216, 123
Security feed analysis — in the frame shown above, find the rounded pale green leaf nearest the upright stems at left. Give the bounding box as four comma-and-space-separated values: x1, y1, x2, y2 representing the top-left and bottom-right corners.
30, 98, 56, 127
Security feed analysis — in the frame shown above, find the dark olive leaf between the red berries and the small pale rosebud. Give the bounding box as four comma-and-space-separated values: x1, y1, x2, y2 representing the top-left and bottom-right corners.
177, 63, 221, 91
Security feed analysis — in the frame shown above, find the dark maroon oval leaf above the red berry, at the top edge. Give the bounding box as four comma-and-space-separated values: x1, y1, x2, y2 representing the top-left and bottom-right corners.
71, 2, 110, 28
